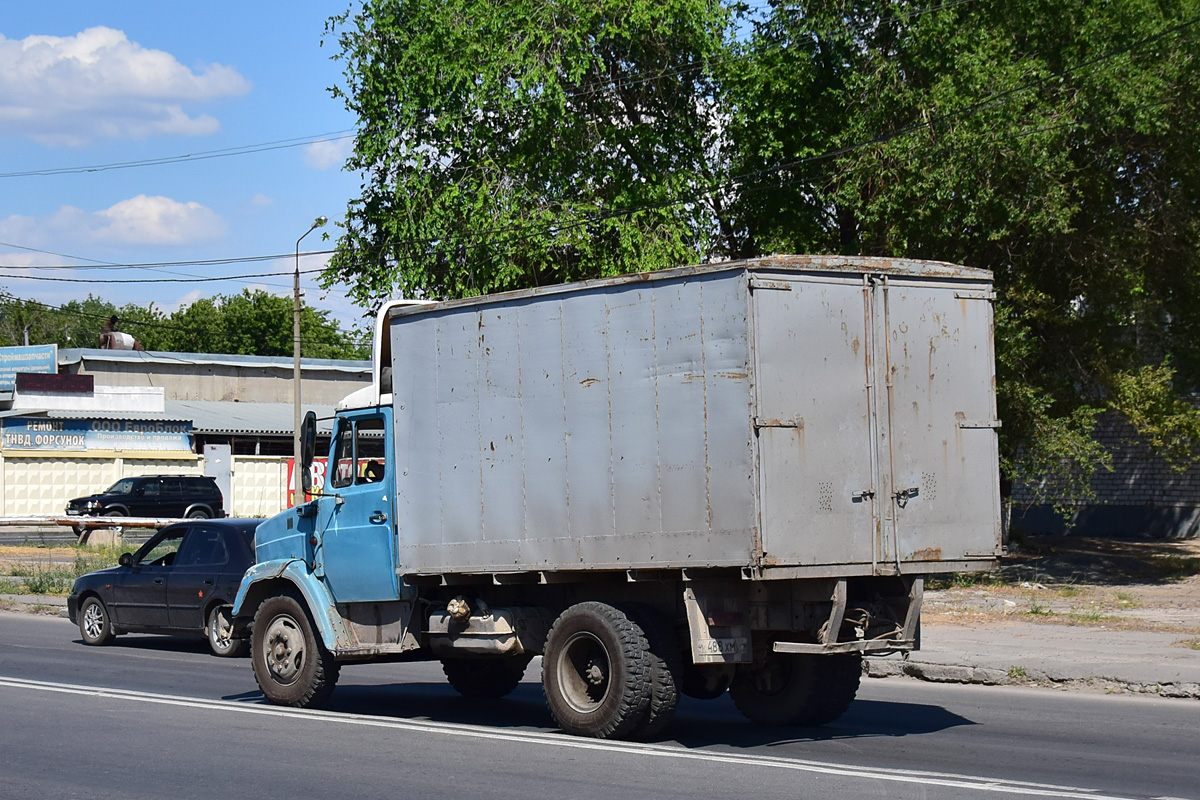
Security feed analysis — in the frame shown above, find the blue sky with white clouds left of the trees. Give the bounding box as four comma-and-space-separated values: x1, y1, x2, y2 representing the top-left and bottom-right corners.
0, 0, 364, 338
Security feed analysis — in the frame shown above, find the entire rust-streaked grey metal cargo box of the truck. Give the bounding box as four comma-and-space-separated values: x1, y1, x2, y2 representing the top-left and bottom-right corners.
390, 257, 1001, 579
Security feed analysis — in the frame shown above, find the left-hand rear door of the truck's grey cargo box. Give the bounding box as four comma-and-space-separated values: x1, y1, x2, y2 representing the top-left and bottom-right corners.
751, 276, 877, 566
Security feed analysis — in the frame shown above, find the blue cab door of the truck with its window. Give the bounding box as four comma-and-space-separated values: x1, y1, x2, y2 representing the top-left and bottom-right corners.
314, 408, 400, 602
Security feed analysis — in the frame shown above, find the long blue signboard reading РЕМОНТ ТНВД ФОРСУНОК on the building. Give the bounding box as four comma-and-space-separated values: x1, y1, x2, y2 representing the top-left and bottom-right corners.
0, 417, 192, 452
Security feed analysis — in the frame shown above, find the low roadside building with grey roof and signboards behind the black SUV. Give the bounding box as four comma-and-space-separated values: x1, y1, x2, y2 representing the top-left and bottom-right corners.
0, 349, 371, 517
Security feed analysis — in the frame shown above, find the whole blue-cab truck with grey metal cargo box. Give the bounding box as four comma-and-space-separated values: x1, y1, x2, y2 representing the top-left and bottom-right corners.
226, 255, 1002, 739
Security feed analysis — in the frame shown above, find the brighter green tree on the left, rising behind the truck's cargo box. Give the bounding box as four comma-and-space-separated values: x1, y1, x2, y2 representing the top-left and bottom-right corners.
326, 0, 728, 307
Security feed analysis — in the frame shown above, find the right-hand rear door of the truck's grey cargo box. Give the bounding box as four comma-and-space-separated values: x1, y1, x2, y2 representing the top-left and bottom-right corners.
875, 278, 1000, 569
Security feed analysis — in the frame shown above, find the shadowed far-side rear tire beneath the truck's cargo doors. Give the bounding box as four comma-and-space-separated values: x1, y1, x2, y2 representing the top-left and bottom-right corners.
730, 650, 863, 726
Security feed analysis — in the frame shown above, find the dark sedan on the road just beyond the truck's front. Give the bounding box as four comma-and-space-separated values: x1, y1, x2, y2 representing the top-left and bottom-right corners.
67, 519, 262, 656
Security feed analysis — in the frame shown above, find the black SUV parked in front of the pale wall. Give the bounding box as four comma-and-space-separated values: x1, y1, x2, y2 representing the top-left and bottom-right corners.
67, 475, 224, 519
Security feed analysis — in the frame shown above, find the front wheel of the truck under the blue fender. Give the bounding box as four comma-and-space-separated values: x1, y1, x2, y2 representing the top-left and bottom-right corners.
251, 594, 338, 709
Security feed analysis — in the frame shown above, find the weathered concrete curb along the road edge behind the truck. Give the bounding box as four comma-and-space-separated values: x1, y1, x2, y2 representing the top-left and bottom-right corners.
863, 658, 1200, 699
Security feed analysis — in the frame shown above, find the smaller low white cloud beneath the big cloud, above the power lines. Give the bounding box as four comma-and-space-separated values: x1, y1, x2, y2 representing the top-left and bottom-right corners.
0, 194, 226, 249
